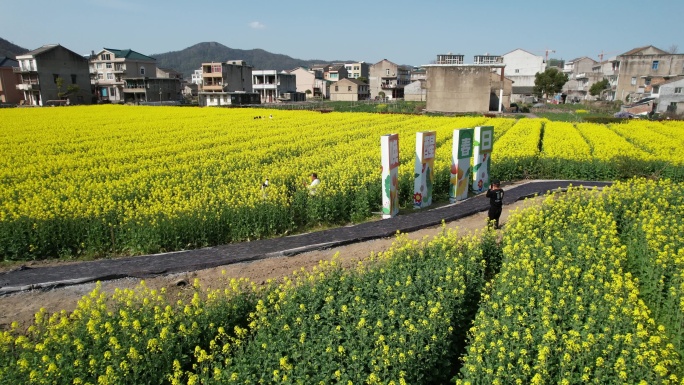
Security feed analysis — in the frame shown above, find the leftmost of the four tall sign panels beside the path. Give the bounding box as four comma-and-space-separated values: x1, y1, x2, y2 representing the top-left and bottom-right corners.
380, 134, 399, 219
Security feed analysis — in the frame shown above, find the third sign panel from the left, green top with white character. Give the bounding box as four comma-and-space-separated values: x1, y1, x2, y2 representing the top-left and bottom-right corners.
449, 128, 475, 203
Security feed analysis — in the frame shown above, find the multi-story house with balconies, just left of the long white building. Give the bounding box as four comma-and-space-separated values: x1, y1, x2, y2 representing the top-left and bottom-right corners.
198, 60, 258, 106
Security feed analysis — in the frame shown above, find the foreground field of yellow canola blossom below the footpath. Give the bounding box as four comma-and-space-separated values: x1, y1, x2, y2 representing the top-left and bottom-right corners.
0, 179, 684, 385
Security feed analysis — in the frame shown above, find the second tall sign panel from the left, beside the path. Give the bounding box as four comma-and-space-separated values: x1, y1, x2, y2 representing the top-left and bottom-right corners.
413, 131, 437, 209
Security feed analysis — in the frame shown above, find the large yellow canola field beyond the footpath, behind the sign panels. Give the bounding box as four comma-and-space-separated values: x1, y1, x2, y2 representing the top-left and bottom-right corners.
0, 106, 684, 261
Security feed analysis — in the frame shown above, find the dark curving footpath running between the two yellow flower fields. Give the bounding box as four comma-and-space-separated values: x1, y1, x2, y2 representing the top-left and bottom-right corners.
0, 180, 611, 295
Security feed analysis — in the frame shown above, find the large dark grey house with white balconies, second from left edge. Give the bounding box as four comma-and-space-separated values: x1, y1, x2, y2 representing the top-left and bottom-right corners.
15, 44, 92, 106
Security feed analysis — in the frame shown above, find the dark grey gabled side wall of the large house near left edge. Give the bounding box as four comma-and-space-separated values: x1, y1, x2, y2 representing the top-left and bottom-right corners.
36, 47, 92, 105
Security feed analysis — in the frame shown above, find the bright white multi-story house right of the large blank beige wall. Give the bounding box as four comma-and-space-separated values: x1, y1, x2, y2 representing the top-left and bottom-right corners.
502, 48, 546, 102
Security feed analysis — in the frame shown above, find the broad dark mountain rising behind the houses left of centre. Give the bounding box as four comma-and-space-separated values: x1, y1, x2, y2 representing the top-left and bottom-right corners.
150, 42, 352, 78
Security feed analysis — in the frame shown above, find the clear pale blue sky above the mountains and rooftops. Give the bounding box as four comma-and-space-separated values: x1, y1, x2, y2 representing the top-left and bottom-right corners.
0, 0, 684, 65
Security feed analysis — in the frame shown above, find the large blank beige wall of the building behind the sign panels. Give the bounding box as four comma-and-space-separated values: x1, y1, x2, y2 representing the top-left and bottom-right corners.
427, 65, 491, 113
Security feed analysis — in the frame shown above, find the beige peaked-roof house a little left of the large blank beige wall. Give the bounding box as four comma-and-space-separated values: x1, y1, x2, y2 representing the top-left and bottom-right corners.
368, 59, 411, 99
